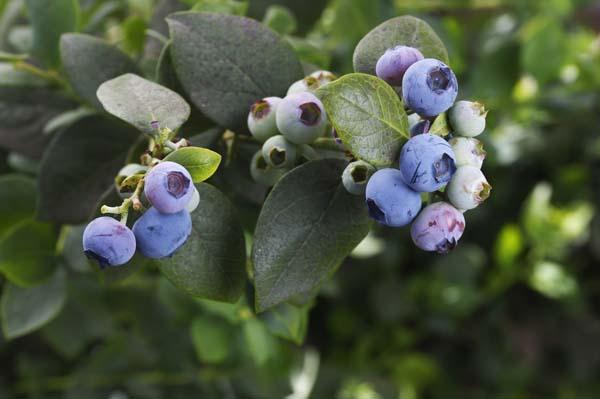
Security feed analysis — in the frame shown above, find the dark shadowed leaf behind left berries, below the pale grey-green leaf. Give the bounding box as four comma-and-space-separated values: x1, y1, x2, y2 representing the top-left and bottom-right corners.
38, 116, 139, 224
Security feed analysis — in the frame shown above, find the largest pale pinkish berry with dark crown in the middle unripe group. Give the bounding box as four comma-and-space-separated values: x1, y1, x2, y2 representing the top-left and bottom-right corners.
277, 93, 328, 144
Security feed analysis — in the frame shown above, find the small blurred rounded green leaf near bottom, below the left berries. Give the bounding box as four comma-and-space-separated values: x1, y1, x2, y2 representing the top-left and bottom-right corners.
190, 316, 231, 364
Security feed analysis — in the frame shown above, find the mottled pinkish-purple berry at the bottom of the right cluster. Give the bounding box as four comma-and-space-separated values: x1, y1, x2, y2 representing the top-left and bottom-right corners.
410, 202, 465, 254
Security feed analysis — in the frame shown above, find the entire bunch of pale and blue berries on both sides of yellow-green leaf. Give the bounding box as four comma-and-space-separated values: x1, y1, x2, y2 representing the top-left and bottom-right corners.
248, 46, 491, 253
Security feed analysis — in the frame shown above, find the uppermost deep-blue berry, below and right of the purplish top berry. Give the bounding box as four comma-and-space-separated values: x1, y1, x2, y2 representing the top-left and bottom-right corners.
402, 58, 458, 118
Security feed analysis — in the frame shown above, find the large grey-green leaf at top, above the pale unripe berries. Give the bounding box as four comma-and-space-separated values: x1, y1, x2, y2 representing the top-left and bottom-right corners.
167, 12, 303, 131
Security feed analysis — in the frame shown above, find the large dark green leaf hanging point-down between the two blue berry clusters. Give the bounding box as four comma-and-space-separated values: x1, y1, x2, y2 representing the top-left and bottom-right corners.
252, 159, 369, 311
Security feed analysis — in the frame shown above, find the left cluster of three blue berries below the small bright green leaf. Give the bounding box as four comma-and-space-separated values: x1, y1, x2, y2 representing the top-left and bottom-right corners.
83, 161, 200, 268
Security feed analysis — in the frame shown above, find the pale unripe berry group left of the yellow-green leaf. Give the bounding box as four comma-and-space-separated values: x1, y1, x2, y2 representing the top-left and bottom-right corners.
248, 71, 336, 186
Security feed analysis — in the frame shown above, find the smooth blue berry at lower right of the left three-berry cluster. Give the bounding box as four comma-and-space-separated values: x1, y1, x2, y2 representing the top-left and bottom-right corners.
133, 207, 192, 259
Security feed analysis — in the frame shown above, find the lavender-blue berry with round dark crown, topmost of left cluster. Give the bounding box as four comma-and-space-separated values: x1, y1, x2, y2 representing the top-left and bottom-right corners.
144, 161, 194, 213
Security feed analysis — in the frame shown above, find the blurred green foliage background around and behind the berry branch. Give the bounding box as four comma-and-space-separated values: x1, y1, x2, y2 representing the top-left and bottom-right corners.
0, 0, 600, 399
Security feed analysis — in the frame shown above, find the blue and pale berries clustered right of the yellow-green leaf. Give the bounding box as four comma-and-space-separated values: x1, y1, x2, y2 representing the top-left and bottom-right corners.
356, 46, 491, 253
